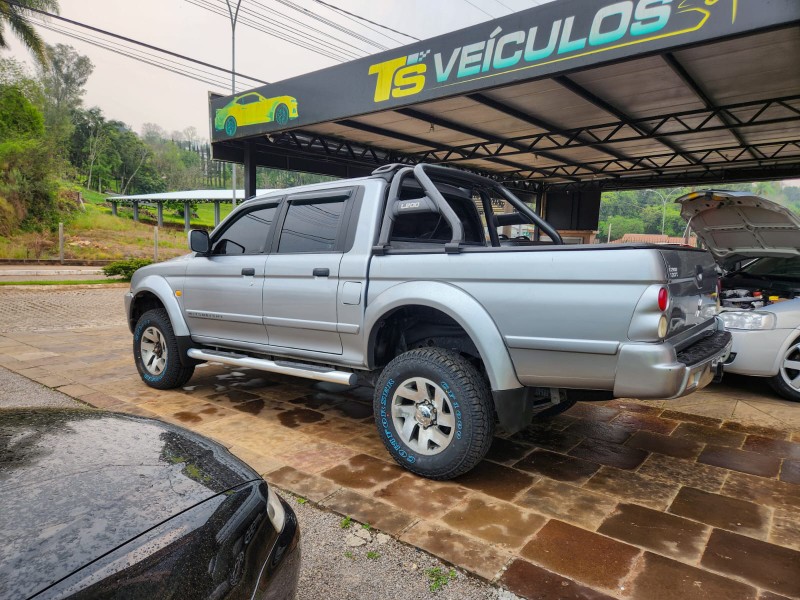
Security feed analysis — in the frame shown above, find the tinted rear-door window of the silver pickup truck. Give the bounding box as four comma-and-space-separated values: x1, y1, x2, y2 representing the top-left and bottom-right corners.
278, 200, 344, 253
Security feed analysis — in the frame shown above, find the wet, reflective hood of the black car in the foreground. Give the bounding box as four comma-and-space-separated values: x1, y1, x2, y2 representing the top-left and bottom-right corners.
0, 410, 259, 597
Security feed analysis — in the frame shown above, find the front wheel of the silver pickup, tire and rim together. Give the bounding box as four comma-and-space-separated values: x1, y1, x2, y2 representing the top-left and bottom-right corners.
133, 308, 194, 390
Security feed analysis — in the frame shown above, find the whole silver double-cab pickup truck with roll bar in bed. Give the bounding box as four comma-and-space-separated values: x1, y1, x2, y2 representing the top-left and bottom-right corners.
126, 165, 731, 479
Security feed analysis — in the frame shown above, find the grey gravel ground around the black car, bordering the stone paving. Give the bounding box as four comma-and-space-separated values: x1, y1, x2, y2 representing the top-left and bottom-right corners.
0, 367, 516, 600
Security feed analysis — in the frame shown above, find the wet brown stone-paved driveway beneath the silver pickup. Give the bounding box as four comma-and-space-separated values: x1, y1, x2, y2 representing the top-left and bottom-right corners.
0, 289, 800, 600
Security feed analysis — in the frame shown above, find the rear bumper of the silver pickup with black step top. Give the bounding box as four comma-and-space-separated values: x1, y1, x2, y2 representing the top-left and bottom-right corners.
614, 330, 731, 399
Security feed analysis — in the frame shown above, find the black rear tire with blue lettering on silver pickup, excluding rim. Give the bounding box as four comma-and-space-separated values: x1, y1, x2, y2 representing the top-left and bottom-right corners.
373, 348, 494, 479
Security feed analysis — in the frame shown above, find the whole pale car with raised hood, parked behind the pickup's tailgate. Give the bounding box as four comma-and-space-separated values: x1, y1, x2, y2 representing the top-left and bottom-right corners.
676, 191, 800, 402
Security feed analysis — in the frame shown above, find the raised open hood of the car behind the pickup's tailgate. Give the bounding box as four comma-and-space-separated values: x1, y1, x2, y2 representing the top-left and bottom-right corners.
675, 190, 800, 265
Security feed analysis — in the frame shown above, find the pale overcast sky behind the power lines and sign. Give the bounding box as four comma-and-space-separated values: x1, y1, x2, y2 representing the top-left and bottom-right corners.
0, 0, 550, 138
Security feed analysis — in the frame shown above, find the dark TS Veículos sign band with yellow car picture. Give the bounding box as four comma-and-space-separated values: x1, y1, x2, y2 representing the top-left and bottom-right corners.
210, 0, 800, 141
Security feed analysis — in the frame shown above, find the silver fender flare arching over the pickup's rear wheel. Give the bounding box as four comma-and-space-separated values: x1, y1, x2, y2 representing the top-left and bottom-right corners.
364, 281, 523, 390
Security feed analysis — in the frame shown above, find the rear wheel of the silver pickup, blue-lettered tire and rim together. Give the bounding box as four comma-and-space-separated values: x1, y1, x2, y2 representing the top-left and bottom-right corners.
374, 348, 494, 479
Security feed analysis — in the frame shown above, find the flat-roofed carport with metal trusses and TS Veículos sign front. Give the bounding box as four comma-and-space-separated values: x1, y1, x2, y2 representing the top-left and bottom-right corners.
209, 0, 800, 214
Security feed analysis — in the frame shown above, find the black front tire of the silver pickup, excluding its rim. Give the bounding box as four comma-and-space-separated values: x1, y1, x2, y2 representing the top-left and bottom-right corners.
133, 308, 194, 390
